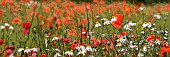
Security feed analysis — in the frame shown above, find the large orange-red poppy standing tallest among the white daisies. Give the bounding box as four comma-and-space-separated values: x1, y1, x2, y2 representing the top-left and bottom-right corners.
111, 14, 124, 29
